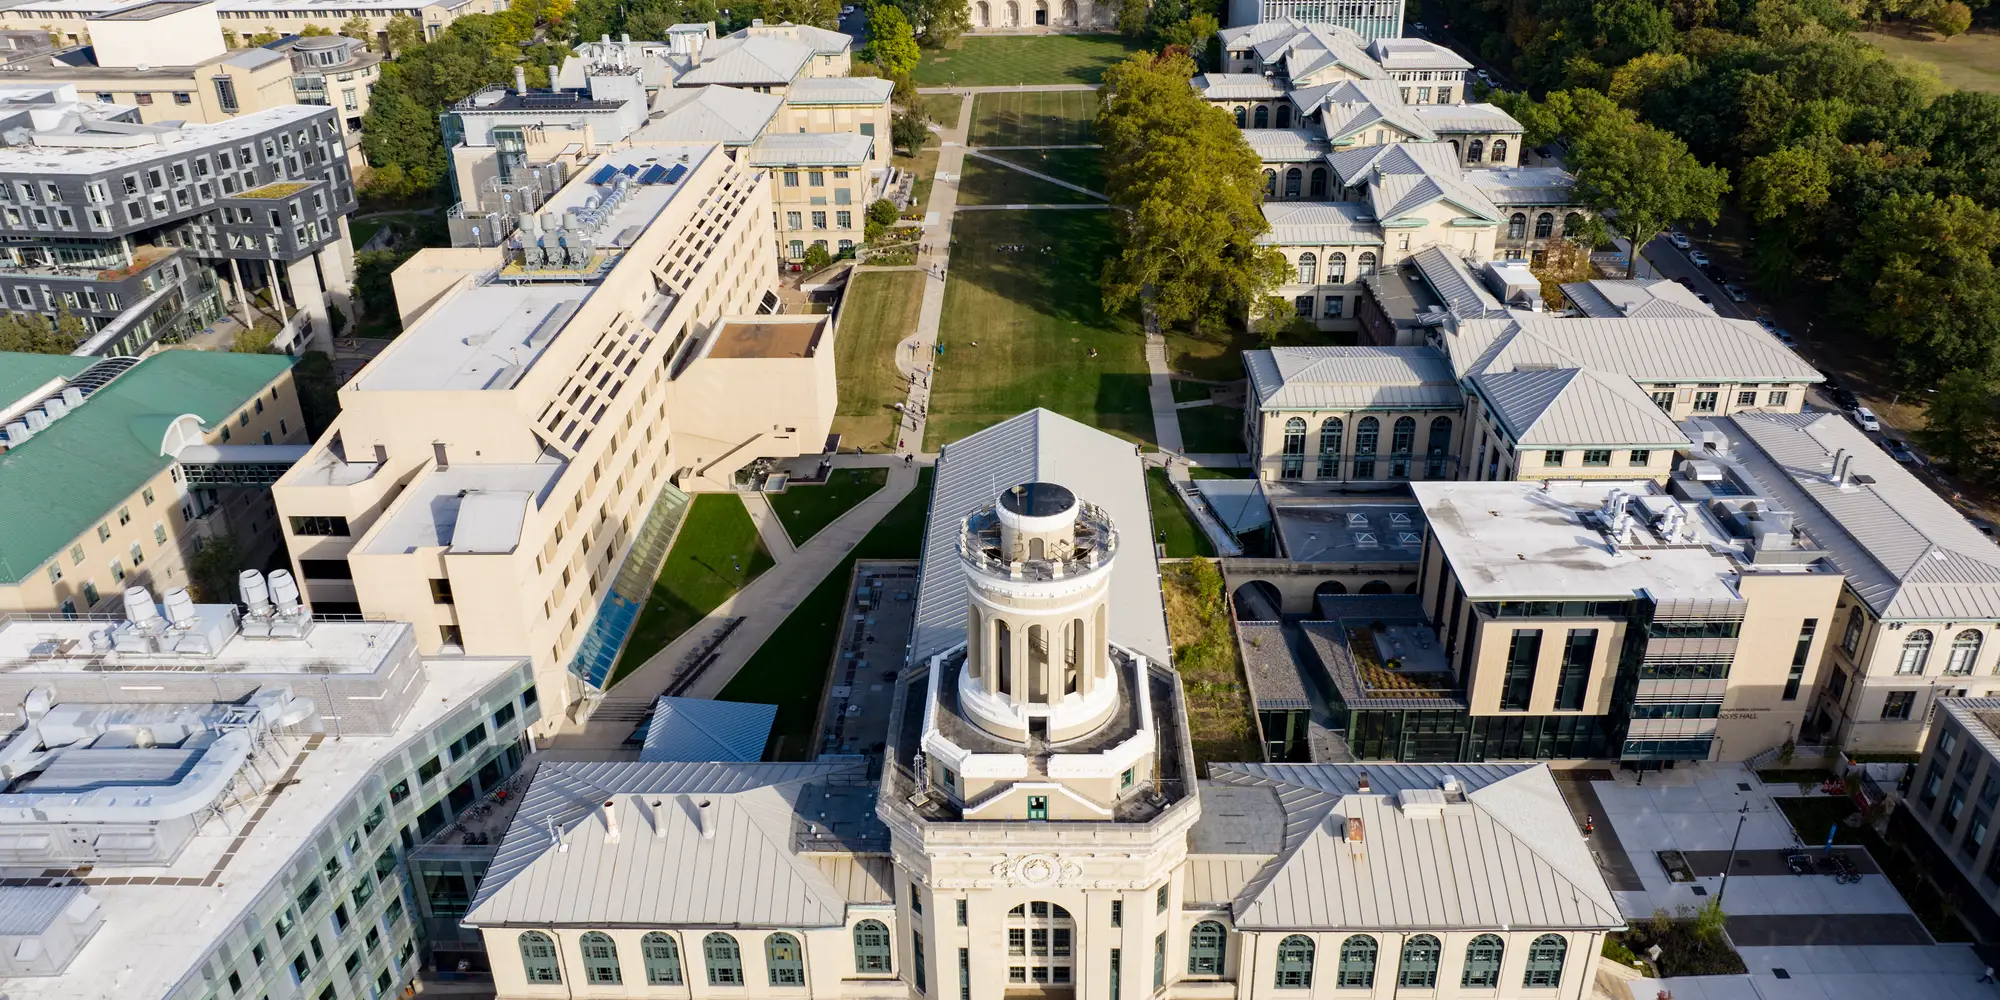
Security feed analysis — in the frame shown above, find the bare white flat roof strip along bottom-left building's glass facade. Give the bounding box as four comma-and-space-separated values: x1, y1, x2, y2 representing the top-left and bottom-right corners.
6, 656, 522, 1000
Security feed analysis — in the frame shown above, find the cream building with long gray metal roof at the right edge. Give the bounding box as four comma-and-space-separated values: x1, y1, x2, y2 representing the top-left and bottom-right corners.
1686, 414, 2000, 752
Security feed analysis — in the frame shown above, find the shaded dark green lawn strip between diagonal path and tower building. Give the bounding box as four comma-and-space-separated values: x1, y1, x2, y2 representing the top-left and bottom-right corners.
718, 468, 930, 760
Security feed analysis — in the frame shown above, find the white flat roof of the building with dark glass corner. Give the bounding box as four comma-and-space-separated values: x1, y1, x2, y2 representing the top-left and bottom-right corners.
1410, 480, 1742, 600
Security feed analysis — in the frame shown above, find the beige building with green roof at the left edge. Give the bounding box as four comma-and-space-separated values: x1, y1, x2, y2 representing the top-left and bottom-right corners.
0, 350, 306, 616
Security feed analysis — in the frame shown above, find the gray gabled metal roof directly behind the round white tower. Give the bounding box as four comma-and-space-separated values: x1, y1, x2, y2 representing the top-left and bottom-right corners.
910, 408, 1172, 664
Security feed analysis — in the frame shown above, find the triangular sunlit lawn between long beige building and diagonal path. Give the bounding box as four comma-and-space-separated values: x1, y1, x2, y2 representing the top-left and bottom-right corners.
612, 494, 772, 684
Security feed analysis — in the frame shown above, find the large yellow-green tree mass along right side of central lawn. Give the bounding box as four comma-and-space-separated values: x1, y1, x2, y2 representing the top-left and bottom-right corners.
1096, 52, 1284, 332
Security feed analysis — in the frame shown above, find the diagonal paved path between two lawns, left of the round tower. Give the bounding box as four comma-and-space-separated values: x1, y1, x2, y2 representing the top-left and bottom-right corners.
554, 454, 916, 752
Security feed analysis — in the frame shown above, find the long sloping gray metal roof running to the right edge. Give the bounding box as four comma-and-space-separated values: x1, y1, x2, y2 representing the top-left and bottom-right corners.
1712, 414, 2000, 622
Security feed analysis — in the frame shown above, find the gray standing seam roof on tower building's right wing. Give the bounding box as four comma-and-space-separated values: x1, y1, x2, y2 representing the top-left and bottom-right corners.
1210, 764, 1626, 930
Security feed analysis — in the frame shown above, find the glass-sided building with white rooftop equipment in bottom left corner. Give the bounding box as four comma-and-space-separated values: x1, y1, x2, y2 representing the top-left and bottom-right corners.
0, 574, 540, 1000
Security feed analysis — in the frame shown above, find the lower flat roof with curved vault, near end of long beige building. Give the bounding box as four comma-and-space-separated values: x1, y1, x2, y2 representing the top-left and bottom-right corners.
368, 462, 568, 556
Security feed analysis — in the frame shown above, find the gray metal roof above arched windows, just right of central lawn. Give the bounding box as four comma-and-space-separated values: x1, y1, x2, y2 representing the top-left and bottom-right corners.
1244, 348, 1464, 410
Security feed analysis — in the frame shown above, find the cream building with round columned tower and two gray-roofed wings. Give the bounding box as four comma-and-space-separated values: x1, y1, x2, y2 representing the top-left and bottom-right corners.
466, 410, 1624, 1000
